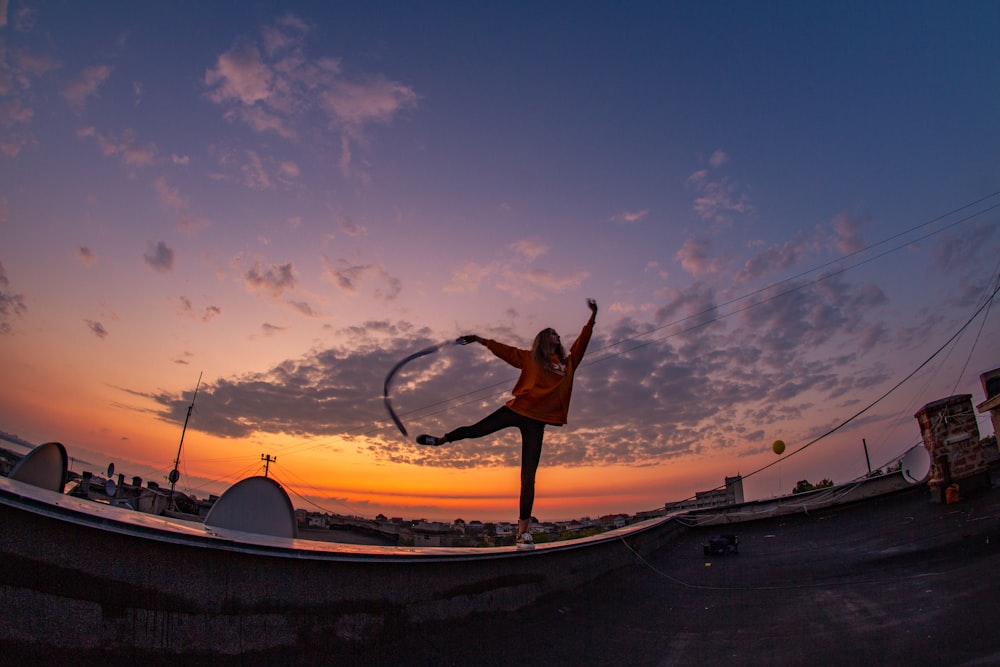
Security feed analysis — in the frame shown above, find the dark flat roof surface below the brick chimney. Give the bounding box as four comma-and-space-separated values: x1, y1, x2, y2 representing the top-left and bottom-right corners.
352, 486, 1000, 666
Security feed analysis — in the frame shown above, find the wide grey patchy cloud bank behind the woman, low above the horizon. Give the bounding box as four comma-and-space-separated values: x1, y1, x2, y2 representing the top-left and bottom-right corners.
139, 288, 883, 468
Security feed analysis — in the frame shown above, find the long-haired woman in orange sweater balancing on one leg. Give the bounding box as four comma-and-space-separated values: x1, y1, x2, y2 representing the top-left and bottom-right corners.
417, 299, 597, 549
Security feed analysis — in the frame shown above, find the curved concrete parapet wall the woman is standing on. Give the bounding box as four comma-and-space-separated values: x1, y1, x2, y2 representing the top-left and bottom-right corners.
0, 479, 684, 658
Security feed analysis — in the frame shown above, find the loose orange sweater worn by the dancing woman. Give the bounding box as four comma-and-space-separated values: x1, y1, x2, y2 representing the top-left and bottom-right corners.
484, 320, 594, 426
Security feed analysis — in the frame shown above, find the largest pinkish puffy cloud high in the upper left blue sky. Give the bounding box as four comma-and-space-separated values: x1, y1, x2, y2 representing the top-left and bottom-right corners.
204, 14, 418, 177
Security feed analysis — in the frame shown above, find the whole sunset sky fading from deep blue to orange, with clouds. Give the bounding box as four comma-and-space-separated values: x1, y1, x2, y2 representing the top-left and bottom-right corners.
0, 0, 1000, 521
